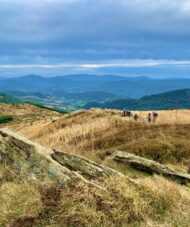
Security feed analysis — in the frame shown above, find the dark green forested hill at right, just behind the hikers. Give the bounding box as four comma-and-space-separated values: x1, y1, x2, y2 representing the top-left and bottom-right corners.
84, 89, 190, 110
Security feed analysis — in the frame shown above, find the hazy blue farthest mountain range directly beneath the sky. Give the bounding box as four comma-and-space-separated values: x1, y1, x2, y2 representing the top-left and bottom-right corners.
0, 74, 190, 98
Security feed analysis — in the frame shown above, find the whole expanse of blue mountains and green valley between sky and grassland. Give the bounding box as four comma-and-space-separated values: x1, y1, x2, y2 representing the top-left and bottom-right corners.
0, 75, 190, 112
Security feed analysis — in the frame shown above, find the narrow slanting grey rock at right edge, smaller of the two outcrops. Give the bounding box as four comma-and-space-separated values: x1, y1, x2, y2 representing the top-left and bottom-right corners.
110, 151, 190, 183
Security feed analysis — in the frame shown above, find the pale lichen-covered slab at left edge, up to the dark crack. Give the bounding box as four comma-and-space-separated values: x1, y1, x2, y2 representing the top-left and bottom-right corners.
0, 129, 77, 182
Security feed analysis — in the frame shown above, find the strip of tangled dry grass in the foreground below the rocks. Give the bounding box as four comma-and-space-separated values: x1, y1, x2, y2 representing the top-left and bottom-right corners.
0, 177, 190, 227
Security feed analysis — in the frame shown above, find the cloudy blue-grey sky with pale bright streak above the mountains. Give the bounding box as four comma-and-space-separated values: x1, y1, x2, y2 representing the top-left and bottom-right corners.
0, 0, 190, 78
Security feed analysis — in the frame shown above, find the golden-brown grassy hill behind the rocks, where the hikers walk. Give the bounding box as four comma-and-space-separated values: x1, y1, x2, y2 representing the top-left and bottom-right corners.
22, 109, 190, 171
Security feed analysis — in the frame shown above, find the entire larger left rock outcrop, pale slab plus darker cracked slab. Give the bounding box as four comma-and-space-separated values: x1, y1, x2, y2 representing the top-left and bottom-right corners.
0, 129, 122, 183
